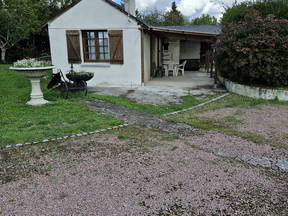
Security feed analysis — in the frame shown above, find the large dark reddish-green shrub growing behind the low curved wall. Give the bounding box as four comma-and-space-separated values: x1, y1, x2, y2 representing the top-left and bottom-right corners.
216, 9, 288, 87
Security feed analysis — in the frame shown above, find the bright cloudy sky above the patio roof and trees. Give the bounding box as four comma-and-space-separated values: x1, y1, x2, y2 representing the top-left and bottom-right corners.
114, 0, 245, 18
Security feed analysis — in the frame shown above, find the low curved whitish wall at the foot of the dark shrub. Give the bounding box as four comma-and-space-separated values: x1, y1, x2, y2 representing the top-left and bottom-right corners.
220, 77, 288, 101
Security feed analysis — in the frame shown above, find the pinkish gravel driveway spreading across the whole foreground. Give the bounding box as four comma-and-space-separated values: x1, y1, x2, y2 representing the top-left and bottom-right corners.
0, 128, 288, 216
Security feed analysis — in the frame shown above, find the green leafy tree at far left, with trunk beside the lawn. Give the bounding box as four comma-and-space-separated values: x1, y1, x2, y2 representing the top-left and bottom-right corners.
0, 0, 41, 62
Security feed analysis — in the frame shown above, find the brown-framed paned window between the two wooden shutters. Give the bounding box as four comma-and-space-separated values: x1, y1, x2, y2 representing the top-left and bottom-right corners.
82, 30, 110, 62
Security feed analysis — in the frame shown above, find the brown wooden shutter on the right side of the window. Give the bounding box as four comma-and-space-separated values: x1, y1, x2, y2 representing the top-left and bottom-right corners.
109, 30, 124, 64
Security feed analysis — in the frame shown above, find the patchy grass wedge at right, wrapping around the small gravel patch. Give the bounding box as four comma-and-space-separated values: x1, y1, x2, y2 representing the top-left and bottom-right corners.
167, 94, 288, 148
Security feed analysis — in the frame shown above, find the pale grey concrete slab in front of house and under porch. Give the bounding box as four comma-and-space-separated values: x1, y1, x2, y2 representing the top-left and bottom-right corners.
89, 72, 215, 105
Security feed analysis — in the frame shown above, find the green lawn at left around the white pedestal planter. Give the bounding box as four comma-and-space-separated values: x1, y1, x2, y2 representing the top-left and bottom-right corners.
0, 65, 121, 146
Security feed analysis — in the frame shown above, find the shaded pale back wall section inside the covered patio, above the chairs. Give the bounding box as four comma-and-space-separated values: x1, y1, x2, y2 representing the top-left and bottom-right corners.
180, 41, 201, 59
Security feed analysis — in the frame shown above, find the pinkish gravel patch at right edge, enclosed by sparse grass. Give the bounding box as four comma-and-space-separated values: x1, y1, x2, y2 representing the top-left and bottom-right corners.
197, 105, 288, 148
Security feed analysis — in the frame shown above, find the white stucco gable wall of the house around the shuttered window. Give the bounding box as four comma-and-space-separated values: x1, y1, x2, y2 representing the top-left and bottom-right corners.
48, 0, 141, 86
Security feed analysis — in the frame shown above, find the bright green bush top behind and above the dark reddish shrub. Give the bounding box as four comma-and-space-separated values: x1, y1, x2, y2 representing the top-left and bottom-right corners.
221, 0, 288, 25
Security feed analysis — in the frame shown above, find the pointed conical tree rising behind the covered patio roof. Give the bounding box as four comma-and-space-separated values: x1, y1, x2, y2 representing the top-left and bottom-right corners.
164, 1, 187, 26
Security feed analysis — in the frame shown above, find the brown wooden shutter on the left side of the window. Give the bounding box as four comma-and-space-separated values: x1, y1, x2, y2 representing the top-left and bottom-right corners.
66, 31, 81, 64
